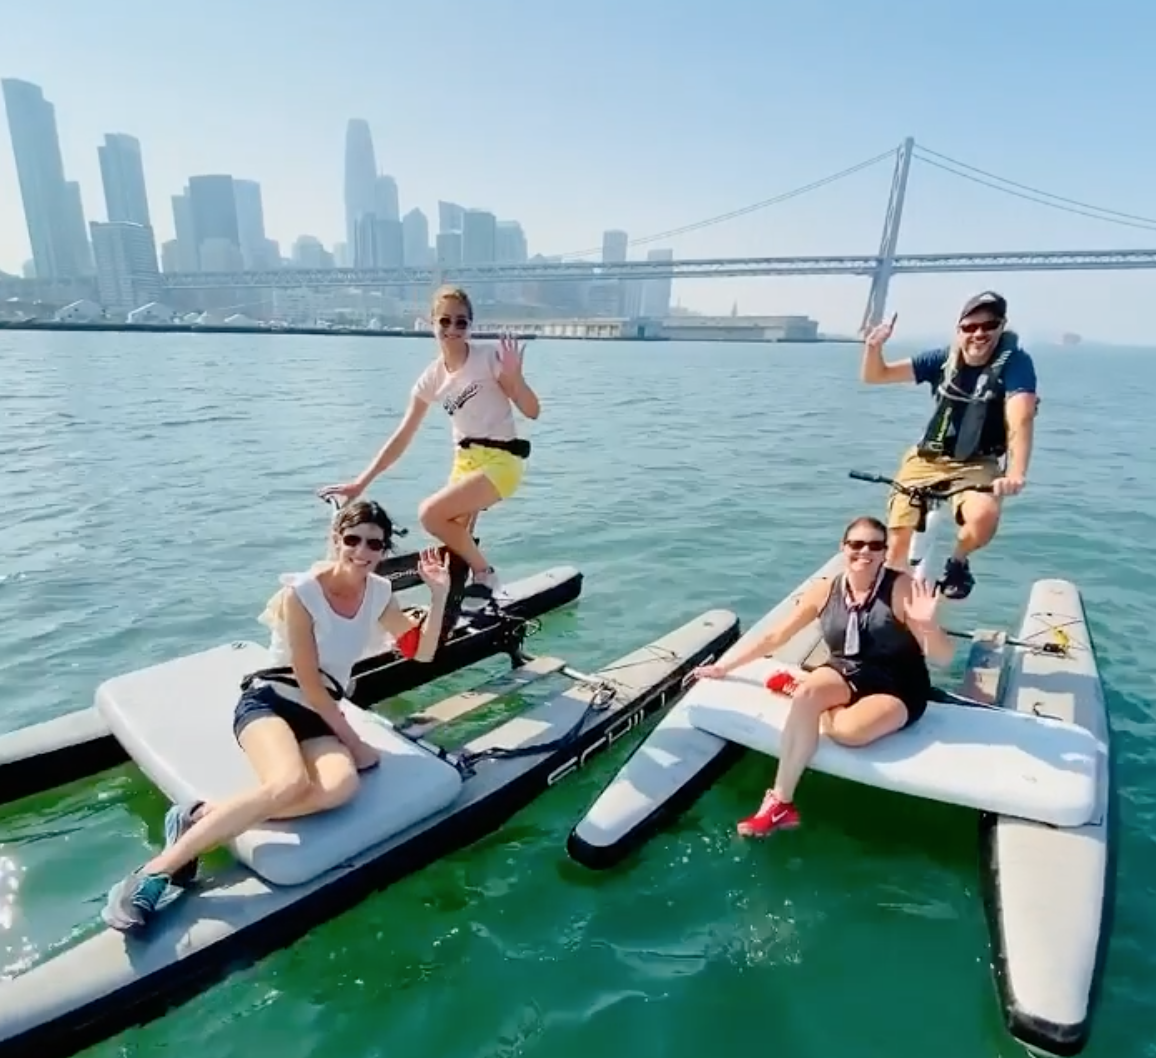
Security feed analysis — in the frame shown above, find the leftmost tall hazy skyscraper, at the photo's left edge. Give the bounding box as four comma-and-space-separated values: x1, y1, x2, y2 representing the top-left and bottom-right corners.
0, 79, 91, 279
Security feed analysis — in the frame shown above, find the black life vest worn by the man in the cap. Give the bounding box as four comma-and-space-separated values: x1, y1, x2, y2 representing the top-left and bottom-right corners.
919, 331, 1020, 461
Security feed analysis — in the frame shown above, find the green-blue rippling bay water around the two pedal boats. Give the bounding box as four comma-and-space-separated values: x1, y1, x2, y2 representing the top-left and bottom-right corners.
0, 333, 1156, 1058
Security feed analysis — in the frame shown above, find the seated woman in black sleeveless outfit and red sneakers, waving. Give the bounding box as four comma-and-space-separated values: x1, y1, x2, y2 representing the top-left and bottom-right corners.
694, 517, 954, 837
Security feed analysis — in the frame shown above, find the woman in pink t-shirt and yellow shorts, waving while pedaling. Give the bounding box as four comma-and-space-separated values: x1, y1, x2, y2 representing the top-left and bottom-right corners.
320, 287, 541, 601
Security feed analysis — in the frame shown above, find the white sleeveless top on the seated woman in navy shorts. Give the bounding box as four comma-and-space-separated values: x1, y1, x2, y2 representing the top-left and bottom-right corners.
262, 572, 393, 689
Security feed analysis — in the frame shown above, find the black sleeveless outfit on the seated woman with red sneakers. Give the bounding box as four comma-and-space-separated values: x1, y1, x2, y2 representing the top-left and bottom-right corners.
818, 569, 932, 727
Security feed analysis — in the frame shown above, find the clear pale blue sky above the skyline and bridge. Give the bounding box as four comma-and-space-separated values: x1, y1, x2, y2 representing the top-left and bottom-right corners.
0, 0, 1156, 342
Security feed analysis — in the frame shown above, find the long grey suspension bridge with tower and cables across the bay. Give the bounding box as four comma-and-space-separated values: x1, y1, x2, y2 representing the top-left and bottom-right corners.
163, 136, 1156, 327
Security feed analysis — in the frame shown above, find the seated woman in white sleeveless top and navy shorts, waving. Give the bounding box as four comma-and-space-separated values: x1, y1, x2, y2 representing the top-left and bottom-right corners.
102, 501, 450, 930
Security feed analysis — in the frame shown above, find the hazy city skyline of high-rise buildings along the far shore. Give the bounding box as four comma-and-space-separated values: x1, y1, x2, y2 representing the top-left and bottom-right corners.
0, 79, 673, 324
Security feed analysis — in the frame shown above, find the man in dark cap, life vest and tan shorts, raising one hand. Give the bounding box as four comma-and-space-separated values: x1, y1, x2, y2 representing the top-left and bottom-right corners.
861, 290, 1038, 599
